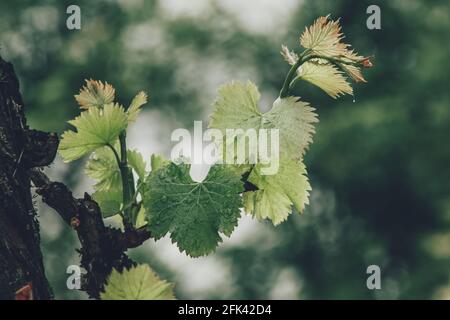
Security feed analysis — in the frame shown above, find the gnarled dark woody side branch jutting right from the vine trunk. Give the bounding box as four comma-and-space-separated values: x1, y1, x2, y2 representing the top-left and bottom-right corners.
31, 169, 150, 298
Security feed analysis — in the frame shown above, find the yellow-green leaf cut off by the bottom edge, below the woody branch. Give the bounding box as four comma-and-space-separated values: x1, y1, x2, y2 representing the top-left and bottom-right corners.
100, 264, 175, 300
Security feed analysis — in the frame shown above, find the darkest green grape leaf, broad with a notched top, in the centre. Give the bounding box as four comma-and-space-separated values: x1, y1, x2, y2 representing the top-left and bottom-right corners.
143, 163, 243, 257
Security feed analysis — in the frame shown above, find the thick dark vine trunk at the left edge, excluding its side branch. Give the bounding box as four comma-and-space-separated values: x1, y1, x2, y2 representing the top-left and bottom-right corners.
0, 57, 58, 299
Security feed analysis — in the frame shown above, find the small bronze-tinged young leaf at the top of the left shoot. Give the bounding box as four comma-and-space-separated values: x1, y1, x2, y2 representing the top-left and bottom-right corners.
75, 79, 115, 109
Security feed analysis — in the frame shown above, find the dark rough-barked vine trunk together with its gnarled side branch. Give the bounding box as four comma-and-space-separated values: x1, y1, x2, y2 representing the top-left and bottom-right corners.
0, 57, 150, 299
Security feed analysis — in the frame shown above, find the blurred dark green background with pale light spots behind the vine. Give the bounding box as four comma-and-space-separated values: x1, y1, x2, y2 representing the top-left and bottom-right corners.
0, 0, 450, 299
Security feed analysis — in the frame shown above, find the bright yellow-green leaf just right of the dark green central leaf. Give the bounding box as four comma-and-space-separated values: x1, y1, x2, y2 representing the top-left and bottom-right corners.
243, 160, 311, 225
